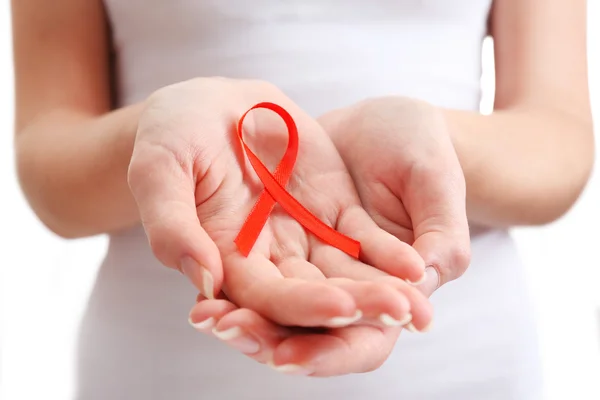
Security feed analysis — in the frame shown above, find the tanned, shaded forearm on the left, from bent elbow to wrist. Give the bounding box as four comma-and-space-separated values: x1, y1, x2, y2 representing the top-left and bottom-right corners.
15, 105, 141, 238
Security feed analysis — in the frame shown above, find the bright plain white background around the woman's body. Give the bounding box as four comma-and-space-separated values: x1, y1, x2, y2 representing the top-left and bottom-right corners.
0, 0, 600, 400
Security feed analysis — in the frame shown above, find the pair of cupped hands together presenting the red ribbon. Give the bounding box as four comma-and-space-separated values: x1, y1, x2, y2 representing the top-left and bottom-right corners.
128, 78, 469, 376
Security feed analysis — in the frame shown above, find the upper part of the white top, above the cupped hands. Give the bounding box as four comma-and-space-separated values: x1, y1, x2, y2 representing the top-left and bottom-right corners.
105, 0, 491, 112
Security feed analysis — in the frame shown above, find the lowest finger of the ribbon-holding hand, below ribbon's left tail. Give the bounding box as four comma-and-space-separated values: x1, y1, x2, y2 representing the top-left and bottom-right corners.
225, 253, 360, 327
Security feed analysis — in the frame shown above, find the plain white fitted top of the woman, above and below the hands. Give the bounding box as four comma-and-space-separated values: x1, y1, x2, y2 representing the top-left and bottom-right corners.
78, 0, 541, 400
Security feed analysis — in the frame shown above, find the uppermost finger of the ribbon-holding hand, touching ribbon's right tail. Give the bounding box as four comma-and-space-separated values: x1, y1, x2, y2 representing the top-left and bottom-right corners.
338, 207, 425, 283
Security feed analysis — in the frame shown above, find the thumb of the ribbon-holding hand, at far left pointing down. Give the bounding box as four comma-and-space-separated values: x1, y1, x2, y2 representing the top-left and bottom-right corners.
128, 143, 223, 298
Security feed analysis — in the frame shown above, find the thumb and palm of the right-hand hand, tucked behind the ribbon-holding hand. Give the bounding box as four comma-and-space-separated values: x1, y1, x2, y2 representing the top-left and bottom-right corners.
319, 97, 470, 295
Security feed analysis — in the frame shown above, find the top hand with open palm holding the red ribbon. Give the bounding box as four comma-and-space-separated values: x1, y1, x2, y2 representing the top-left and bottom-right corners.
128, 78, 431, 329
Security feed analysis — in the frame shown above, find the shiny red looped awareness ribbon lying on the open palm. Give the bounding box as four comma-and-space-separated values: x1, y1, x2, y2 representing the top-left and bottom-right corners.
235, 102, 360, 258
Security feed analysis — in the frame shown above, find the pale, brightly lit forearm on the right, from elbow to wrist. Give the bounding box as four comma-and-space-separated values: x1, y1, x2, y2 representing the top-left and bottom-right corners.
445, 110, 594, 227
